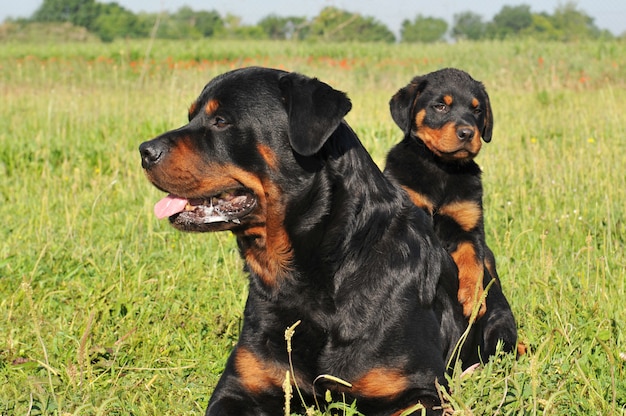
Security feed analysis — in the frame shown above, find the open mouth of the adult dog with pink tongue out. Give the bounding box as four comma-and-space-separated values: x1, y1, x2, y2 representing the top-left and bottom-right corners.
154, 188, 257, 231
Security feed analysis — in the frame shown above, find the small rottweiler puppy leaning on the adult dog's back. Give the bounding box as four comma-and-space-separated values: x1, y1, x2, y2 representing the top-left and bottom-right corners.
384, 68, 523, 358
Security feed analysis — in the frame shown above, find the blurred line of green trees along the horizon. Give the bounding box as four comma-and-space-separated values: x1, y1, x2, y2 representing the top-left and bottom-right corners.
9, 0, 613, 43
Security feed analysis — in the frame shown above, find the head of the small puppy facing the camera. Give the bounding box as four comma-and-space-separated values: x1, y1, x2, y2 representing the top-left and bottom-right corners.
389, 68, 493, 162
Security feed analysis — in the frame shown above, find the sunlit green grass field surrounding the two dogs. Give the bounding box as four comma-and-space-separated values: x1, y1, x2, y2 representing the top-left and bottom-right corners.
0, 41, 626, 416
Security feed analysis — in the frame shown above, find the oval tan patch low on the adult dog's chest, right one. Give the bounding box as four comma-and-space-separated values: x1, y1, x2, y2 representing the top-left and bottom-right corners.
352, 368, 410, 399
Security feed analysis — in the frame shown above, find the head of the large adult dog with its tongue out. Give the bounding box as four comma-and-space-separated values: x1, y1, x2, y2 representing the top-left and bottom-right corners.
139, 67, 351, 232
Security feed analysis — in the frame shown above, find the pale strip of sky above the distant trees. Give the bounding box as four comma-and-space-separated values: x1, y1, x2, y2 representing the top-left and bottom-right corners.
0, 0, 626, 35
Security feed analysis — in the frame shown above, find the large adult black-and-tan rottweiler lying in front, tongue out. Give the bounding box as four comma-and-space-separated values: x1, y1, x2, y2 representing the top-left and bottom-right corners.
140, 67, 466, 416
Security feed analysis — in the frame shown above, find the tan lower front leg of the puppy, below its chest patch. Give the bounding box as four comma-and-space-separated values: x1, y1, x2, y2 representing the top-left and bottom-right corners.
450, 241, 486, 318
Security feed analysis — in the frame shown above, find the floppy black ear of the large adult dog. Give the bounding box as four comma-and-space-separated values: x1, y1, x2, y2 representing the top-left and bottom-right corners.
279, 73, 352, 156
